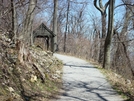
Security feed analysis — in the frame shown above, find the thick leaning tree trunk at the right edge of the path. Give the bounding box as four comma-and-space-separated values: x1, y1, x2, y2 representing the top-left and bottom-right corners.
103, 0, 115, 69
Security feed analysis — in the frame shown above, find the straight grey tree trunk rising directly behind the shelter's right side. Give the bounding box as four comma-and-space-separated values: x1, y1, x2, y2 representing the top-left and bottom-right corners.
53, 0, 58, 52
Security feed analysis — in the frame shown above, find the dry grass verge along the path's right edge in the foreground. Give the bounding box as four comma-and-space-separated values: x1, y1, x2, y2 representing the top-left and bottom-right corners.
101, 69, 134, 101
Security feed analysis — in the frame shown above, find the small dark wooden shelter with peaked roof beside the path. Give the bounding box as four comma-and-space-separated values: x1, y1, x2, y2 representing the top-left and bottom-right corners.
32, 23, 55, 52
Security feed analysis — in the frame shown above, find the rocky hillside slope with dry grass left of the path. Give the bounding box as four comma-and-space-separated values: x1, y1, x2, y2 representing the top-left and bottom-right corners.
0, 35, 62, 101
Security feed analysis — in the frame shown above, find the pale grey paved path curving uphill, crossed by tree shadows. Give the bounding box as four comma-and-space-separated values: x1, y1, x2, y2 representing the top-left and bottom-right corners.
54, 54, 124, 101
